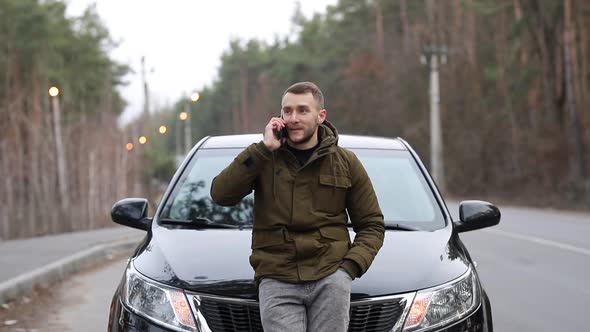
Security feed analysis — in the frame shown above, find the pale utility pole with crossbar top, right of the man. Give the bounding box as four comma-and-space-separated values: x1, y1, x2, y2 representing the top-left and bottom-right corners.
421, 46, 448, 192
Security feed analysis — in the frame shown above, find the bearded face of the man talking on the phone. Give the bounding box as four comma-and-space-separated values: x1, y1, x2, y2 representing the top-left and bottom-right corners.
281, 92, 326, 148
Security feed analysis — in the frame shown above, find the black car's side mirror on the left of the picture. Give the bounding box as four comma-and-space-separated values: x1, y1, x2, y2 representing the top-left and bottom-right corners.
111, 198, 152, 231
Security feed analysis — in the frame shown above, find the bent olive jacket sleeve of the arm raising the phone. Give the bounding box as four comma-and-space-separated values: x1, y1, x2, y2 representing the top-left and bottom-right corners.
211, 141, 272, 206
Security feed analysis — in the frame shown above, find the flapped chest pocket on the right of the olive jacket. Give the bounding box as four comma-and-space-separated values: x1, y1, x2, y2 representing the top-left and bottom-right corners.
312, 174, 352, 215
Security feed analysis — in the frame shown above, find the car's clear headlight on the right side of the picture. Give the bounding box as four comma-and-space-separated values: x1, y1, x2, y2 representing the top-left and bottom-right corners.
403, 267, 480, 332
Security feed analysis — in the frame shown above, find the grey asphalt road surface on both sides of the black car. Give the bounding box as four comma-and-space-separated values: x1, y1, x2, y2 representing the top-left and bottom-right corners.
5, 204, 590, 332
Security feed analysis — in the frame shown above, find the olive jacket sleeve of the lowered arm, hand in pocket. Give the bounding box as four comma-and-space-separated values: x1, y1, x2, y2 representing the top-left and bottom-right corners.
344, 152, 385, 276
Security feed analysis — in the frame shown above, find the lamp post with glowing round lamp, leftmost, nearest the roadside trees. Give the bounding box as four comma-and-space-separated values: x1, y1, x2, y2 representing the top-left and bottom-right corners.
47, 86, 70, 212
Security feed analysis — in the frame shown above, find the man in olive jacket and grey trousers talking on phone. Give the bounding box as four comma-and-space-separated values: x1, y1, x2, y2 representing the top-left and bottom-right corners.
211, 82, 385, 332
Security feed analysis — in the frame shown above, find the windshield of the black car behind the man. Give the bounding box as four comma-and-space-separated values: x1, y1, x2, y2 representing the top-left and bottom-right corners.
160, 149, 445, 230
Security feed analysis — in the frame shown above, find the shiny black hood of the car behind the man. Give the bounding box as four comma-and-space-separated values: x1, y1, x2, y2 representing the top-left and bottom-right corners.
133, 226, 469, 299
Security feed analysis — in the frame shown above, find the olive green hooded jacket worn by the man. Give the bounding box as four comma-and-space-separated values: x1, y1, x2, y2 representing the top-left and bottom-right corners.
211, 121, 385, 283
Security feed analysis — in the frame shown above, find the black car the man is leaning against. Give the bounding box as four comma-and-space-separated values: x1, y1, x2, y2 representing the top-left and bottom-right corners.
108, 135, 500, 332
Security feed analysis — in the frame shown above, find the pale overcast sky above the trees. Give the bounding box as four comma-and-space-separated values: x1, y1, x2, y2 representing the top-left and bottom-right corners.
66, 0, 337, 123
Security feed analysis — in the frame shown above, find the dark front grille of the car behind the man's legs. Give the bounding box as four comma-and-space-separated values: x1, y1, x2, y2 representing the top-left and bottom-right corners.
194, 295, 406, 332
